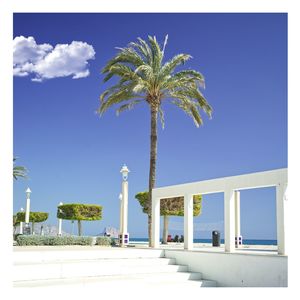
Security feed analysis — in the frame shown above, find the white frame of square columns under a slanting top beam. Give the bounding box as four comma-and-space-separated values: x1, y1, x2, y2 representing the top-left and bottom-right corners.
151, 169, 287, 255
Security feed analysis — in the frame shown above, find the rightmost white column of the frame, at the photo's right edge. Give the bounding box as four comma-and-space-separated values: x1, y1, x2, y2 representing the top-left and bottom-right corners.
276, 183, 287, 255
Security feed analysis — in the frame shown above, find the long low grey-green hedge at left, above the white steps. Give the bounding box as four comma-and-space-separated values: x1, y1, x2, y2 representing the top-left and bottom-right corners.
17, 235, 93, 246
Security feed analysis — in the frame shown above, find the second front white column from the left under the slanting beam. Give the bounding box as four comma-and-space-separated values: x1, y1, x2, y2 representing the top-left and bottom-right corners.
184, 194, 194, 250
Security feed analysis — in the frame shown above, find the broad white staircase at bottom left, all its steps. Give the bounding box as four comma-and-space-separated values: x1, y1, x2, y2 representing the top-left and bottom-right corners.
13, 247, 216, 290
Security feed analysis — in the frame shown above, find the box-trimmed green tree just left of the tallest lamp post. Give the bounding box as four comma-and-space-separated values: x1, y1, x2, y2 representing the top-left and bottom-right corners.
57, 203, 102, 236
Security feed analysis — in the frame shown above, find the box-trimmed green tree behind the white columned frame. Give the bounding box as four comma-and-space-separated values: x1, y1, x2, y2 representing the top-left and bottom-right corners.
135, 192, 202, 244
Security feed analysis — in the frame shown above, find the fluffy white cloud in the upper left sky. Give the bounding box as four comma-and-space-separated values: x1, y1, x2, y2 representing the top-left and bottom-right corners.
13, 36, 95, 81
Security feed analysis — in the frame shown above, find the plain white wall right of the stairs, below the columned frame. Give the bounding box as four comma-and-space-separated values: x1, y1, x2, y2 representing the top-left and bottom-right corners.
165, 249, 288, 287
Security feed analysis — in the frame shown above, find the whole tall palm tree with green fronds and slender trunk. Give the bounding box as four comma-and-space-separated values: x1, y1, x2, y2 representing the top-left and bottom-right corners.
98, 35, 212, 245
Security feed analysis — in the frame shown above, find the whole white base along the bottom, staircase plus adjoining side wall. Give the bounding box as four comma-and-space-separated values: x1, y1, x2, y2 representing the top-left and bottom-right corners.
12, 246, 287, 288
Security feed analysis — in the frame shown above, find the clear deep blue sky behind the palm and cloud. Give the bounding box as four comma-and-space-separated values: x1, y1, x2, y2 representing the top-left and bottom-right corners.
14, 14, 287, 239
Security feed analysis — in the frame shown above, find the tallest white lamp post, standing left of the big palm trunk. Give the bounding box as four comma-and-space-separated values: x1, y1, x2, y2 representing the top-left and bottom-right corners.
119, 164, 130, 247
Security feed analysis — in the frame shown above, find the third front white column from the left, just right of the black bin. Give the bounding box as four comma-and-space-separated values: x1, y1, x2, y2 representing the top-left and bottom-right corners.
224, 189, 235, 252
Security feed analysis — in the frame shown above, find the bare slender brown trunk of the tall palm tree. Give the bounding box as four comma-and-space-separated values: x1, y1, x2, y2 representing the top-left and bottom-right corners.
148, 107, 158, 246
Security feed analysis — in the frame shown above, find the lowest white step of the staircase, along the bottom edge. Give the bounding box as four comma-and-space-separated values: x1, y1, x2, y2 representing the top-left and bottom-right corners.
14, 272, 216, 290
